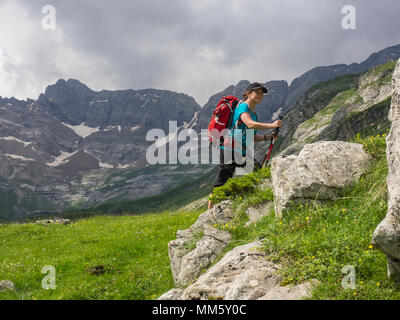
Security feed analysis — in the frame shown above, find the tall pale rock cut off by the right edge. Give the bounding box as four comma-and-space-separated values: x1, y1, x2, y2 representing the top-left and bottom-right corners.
372, 60, 400, 280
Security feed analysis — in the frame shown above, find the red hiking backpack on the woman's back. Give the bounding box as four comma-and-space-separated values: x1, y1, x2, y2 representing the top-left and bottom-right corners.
208, 96, 239, 143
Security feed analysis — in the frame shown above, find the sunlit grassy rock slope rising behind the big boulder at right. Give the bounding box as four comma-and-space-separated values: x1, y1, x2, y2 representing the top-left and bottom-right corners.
275, 61, 396, 155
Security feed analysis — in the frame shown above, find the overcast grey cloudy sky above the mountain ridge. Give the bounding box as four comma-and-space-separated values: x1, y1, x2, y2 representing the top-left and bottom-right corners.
0, 0, 400, 105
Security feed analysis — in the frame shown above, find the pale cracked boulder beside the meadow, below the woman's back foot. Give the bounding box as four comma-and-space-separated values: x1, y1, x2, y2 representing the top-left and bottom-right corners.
168, 201, 234, 287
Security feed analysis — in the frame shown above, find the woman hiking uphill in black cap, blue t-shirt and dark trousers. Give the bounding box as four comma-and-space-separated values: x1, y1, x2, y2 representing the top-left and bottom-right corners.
208, 82, 282, 209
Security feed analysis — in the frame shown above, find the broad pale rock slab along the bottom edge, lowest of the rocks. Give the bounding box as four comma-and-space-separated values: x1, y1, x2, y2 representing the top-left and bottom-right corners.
159, 241, 318, 300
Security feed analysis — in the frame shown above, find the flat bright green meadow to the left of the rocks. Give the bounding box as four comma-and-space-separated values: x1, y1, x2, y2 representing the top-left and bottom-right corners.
0, 210, 204, 300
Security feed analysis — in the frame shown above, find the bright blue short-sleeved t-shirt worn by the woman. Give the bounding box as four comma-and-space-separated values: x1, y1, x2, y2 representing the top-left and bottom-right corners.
221, 102, 257, 155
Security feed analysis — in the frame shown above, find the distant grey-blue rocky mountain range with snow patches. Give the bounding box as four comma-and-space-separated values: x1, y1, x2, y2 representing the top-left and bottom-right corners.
0, 45, 400, 220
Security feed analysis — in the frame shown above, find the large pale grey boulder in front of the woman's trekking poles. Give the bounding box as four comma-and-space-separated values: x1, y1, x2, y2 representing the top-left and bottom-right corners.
271, 141, 371, 217
